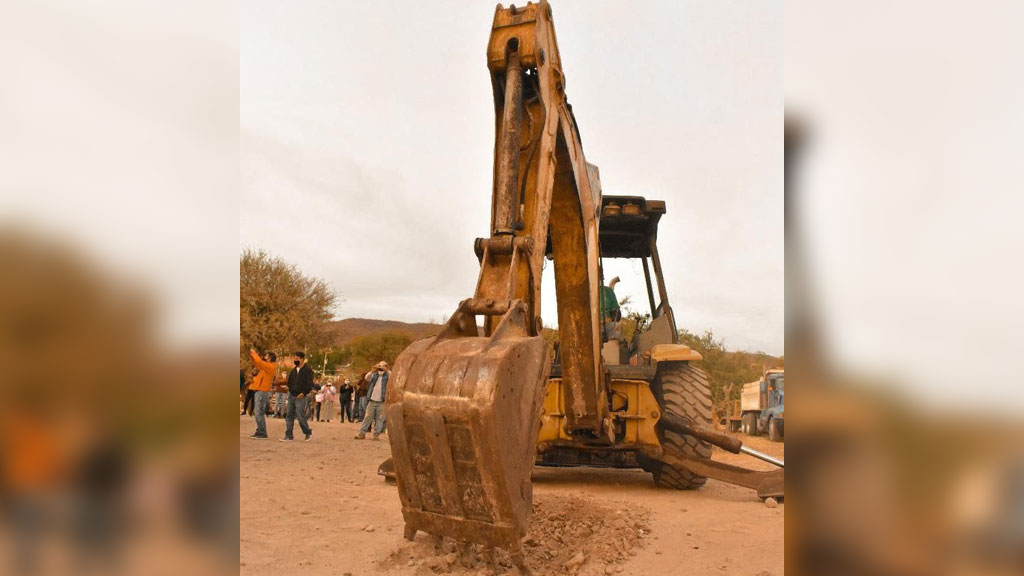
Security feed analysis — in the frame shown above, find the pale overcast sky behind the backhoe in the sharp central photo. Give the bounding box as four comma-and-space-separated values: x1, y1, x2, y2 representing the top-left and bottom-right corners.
240, 0, 783, 355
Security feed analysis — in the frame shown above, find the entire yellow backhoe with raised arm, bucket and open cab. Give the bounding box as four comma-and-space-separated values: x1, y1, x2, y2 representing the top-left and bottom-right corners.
386, 1, 782, 574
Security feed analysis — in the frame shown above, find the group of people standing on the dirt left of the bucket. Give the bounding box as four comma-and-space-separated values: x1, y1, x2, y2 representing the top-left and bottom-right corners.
240, 349, 391, 442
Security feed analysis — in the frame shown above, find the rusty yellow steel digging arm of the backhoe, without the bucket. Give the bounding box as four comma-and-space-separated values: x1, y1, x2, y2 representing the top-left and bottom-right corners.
459, 1, 607, 435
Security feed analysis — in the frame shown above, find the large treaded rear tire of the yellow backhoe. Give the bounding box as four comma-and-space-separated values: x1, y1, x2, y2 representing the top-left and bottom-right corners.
644, 362, 712, 490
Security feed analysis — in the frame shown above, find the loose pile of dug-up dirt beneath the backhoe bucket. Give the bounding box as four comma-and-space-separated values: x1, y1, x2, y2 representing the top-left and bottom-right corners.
380, 495, 650, 576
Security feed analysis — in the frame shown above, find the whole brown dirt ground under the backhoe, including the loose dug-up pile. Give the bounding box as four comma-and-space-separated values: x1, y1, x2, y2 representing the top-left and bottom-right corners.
239, 416, 784, 576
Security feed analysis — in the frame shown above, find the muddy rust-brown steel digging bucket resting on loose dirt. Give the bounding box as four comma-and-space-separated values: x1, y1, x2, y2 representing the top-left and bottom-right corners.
387, 300, 548, 571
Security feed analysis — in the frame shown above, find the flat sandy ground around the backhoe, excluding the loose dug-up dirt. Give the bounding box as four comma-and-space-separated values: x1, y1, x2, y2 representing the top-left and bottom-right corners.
239, 416, 784, 576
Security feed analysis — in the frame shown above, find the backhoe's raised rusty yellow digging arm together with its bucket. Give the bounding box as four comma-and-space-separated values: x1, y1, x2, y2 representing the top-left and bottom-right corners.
387, 1, 608, 572
